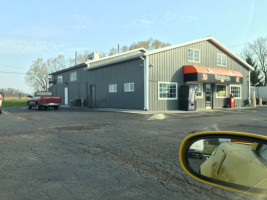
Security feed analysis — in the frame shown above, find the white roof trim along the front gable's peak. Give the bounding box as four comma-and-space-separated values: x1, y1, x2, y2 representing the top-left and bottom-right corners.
145, 36, 254, 71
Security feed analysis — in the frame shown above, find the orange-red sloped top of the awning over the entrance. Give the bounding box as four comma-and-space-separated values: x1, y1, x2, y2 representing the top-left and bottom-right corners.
184, 65, 243, 77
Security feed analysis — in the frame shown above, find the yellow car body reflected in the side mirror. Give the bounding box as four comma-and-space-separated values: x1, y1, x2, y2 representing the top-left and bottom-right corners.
200, 142, 267, 189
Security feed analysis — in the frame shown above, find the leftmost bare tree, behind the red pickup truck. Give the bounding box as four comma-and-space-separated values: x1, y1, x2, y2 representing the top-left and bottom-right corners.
25, 58, 49, 90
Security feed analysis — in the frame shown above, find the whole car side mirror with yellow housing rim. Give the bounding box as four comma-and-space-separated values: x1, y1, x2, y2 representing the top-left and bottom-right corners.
179, 131, 267, 197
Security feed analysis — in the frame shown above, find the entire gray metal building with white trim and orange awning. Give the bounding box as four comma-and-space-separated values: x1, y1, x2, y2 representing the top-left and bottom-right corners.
49, 37, 254, 110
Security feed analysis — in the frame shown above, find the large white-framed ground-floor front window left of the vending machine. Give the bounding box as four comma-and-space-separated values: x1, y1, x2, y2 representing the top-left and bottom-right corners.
158, 82, 177, 100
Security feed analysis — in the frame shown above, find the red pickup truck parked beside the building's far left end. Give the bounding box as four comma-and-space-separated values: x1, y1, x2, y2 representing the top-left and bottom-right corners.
27, 91, 61, 110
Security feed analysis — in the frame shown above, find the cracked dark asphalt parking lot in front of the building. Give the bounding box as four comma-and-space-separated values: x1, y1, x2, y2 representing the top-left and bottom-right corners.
0, 107, 267, 199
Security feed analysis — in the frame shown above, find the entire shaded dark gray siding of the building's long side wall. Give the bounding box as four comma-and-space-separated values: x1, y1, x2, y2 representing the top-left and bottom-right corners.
51, 59, 144, 109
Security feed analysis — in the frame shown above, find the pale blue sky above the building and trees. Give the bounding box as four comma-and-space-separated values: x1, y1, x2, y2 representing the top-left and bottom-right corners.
0, 0, 267, 93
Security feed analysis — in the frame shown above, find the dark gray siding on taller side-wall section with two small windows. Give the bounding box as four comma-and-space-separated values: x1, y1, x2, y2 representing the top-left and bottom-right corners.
88, 59, 144, 109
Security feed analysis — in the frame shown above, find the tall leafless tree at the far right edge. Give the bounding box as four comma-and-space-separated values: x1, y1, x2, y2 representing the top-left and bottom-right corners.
248, 37, 267, 85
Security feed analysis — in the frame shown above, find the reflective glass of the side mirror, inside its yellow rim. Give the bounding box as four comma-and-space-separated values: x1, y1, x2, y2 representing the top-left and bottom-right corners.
187, 138, 267, 189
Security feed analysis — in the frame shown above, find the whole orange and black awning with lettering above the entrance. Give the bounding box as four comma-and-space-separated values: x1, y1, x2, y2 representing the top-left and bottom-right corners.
184, 65, 243, 84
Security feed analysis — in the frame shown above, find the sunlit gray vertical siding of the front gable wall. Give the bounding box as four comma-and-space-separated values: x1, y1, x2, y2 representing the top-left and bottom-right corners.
149, 41, 248, 110
